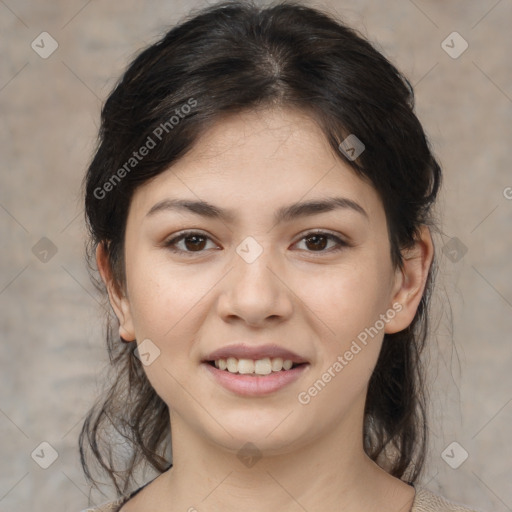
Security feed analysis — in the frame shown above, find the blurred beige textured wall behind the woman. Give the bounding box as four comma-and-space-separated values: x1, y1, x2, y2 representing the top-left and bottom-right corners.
0, 0, 512, 512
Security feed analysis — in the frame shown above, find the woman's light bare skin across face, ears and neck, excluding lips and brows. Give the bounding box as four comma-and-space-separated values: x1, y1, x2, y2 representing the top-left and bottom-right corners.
97, 109, 433, 512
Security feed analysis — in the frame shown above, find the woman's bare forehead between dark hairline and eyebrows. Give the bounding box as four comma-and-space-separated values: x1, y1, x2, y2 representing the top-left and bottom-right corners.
127, 109, 383, 224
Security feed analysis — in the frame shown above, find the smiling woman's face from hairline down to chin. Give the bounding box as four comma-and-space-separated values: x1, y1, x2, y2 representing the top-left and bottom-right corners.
102, 110, 425, 453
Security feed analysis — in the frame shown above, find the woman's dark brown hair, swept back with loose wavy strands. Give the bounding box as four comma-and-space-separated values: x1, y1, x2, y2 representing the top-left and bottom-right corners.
79, 1, 441, 494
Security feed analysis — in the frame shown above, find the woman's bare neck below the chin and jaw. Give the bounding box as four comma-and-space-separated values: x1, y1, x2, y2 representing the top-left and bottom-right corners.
155, 400, 414, 512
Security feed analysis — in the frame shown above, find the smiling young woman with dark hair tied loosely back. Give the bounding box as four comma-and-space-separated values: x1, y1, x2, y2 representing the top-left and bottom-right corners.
80, 2, 484, 512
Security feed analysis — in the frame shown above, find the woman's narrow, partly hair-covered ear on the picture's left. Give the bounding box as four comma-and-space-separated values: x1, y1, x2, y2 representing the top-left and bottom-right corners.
96, 243, 135, 341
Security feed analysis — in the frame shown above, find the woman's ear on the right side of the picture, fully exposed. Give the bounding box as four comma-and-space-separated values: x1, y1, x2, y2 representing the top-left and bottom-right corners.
384, 225, 434, 334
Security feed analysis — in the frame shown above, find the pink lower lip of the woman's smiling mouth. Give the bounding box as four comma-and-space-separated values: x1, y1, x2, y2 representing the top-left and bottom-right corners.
201, 363, 309, 396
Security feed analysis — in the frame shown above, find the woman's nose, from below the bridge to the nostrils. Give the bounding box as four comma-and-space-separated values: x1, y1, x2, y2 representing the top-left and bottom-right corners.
218, 245, 293, 327
